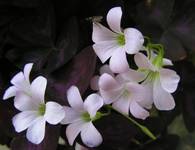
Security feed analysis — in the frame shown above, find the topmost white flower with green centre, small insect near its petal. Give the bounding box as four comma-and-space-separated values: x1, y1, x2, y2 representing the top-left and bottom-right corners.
92, 7, 144, 73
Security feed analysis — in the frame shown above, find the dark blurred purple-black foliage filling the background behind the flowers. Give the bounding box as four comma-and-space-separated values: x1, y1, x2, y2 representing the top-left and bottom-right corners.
0, 0, 195, 150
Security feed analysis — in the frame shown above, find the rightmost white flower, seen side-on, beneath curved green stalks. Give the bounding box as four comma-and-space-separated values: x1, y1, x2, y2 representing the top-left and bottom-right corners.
134, 53, 180, 110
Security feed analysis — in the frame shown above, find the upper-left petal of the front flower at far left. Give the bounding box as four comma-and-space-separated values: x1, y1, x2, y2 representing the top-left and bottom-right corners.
14, 92, 39, 111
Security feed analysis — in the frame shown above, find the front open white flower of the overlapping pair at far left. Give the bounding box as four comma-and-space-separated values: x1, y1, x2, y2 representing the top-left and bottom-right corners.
12, 76, 65, 144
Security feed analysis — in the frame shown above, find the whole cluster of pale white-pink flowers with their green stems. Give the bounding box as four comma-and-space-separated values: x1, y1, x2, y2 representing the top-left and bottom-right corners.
3, 7, 180, 147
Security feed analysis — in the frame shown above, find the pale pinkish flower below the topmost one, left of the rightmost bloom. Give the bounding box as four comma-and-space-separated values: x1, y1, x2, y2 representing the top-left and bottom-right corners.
99, 73, 149, 119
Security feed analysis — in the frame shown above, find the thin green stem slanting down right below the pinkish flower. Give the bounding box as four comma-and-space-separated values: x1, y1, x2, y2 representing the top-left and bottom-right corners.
107, 105, 156, 140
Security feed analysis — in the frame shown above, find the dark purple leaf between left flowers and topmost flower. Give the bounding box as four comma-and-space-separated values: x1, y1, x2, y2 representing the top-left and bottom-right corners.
48, 47, 96, 104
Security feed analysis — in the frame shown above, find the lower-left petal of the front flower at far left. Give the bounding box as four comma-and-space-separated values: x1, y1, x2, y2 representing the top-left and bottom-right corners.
12, 111, 37, 132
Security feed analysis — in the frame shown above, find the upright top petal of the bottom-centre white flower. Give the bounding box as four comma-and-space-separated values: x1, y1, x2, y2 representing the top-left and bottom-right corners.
67, 86, 83, 111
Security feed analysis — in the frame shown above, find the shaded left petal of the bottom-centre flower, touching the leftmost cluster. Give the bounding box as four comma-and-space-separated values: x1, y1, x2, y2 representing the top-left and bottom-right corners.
61, 106, 81, 124
